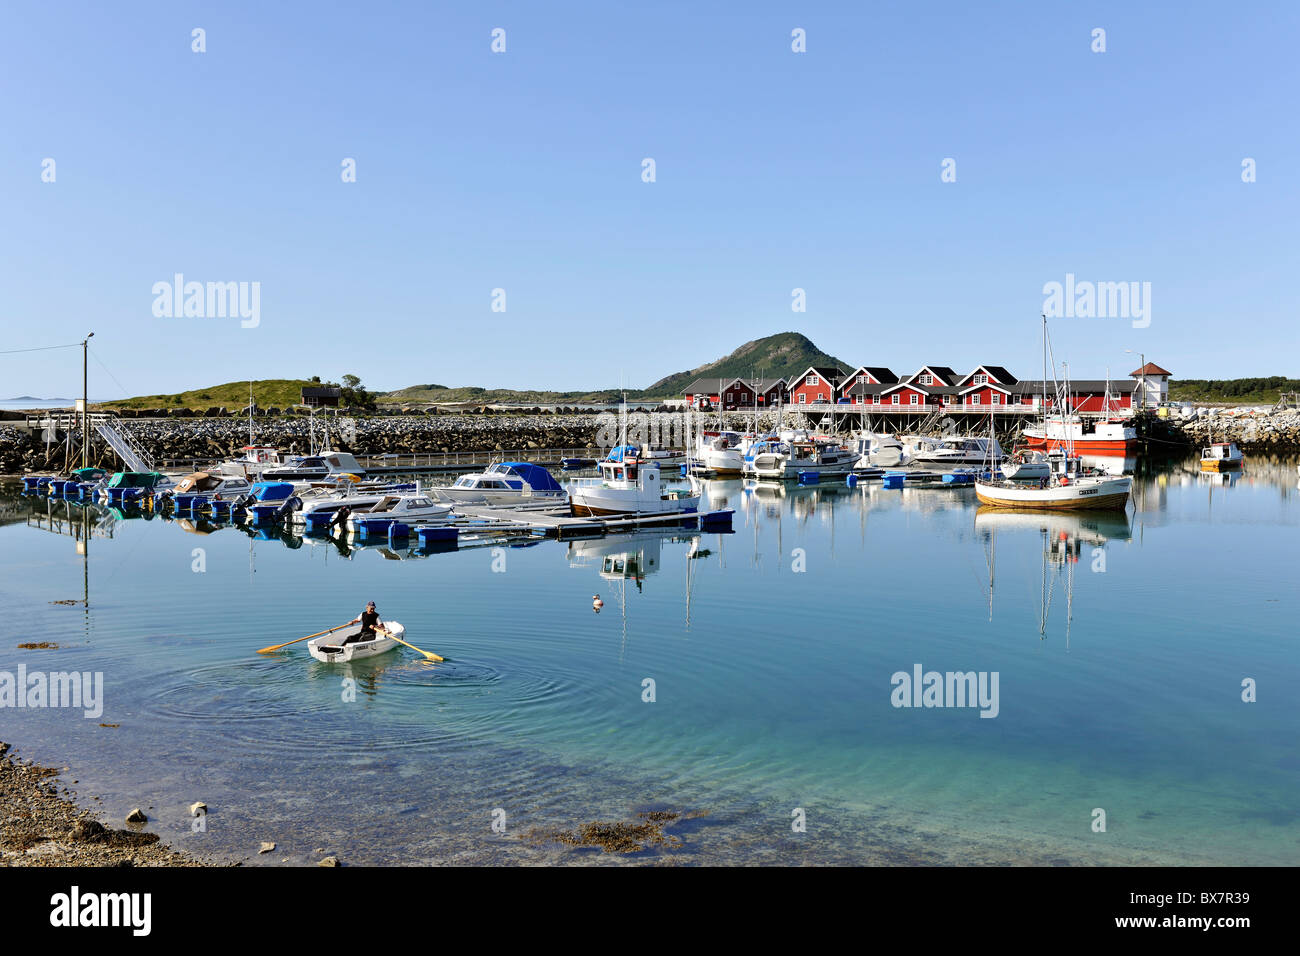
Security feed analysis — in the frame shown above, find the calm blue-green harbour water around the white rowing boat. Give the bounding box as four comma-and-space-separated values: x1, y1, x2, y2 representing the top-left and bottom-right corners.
0, 462, 1300, 865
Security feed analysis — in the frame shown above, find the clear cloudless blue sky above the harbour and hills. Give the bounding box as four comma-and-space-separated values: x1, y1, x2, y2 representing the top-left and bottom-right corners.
0, 3, 1300, 398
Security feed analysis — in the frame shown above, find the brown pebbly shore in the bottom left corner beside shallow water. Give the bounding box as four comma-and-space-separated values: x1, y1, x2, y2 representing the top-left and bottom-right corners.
0, 743, 207, 866
